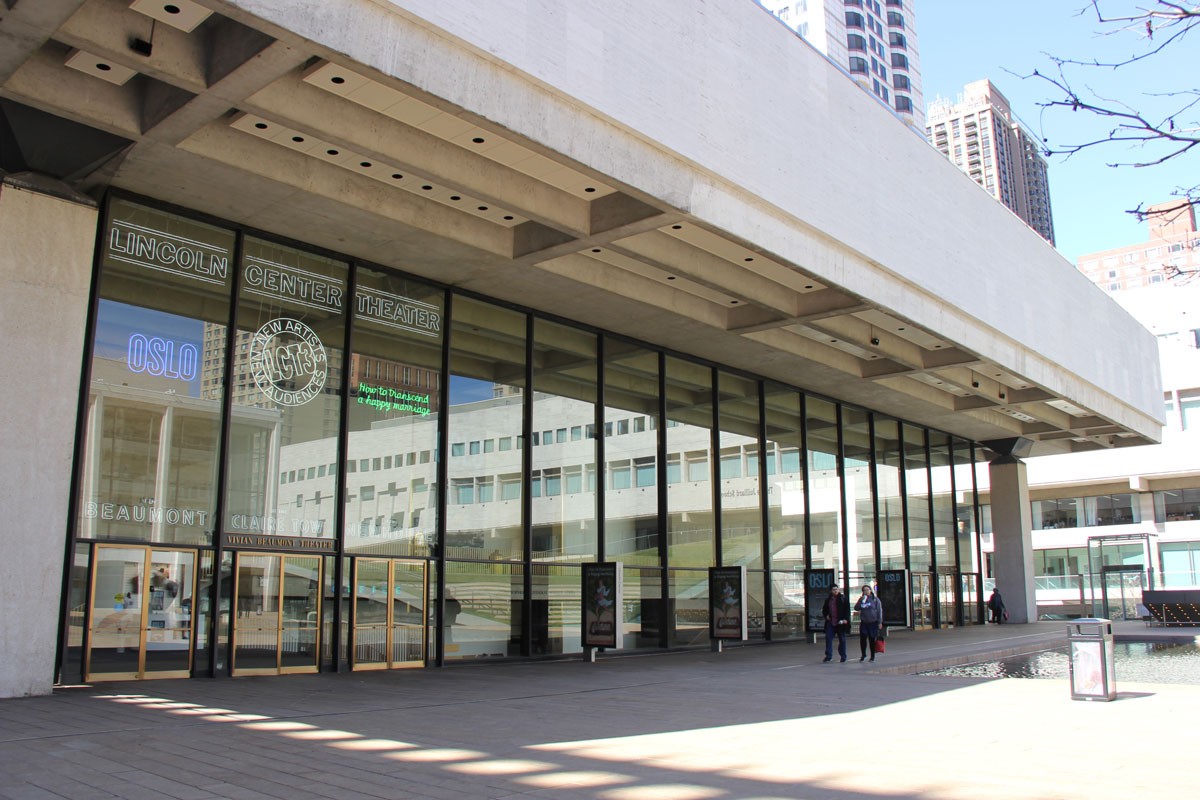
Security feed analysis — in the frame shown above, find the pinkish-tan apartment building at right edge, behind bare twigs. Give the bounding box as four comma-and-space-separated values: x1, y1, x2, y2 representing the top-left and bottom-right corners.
1079, 200, 1200, 296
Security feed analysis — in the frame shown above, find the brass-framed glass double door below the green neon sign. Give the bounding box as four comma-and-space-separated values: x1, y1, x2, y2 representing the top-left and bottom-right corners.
354, 558, 428, 669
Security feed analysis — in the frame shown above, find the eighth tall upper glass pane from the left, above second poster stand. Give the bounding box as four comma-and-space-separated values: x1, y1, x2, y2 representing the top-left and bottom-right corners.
718, 372, 762, 568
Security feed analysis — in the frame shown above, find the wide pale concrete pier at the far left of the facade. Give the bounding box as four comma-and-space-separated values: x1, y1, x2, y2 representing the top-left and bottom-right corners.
0, 184, 97, 697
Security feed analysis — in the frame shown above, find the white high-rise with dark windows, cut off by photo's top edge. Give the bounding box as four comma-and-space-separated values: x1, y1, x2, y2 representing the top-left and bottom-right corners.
758, 0, 925, 131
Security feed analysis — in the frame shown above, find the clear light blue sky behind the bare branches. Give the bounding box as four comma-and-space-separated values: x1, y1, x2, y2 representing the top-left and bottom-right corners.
905, 0, 1200, 264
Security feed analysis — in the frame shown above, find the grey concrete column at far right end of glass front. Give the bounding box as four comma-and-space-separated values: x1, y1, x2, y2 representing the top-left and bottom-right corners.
989, 456, 1038, 622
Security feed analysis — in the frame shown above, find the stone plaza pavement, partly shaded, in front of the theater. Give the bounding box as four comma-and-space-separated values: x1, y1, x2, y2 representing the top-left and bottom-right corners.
0, 622, 1200, 800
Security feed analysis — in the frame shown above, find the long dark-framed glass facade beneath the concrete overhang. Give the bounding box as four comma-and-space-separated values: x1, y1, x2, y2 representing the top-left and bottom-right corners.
62, 198, 988, 679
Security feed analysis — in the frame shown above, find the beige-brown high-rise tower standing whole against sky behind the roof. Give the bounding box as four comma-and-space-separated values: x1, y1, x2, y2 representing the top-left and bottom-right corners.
925, 79, 1054, 245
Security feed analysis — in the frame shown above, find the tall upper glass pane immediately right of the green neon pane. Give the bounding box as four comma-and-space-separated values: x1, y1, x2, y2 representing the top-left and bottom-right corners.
446, 296, 526, 559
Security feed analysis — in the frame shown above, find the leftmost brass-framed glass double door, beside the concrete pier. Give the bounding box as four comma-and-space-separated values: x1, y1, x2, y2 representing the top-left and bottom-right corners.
84, 545, 196, 681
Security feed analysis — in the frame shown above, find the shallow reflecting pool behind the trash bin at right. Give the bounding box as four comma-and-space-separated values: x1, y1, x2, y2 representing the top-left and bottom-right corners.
919, 642, 1200, 685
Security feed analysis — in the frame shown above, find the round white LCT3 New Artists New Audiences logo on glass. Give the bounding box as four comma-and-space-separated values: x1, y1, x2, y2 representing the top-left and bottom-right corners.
250, 317, 329, 405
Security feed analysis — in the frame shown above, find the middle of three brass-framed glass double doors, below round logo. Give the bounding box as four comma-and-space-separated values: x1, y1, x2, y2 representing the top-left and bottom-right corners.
233, 553, 322, 675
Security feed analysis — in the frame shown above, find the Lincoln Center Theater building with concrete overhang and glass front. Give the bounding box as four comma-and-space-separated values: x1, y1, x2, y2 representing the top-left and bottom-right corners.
0, 0, 1162, 696
